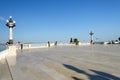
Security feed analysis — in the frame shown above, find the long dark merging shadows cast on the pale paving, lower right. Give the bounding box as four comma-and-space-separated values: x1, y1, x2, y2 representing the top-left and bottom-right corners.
63, 64, 120, 80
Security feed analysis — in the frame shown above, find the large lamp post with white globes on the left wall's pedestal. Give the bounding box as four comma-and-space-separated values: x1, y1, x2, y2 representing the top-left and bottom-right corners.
6, 16, 15, 45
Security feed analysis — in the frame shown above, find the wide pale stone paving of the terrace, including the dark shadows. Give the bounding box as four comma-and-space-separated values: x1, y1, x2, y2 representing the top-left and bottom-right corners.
0, 45, 120, 80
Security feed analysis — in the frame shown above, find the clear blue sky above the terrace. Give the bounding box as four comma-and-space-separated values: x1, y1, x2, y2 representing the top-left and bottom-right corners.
0, 0, 120, 42
